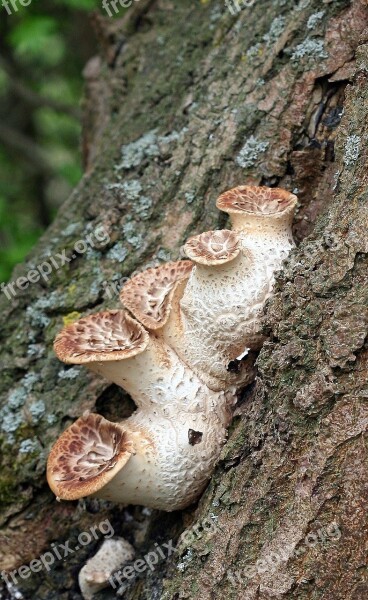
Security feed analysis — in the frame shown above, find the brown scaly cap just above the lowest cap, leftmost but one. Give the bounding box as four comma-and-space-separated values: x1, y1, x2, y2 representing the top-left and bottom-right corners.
54, 310, 149, 365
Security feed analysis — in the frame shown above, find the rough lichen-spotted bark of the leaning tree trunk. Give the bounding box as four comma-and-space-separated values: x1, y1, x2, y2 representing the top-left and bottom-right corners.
0, 0, 368, 600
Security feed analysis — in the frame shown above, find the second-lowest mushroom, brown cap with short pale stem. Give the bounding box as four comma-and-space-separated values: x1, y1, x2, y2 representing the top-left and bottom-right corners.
54, 310, 191, 407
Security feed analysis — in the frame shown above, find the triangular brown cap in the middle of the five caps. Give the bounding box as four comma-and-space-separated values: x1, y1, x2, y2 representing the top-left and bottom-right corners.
120, 260, 193, 330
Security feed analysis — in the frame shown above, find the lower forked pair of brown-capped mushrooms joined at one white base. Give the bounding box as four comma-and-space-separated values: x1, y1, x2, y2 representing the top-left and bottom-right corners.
47, 311, 234, 511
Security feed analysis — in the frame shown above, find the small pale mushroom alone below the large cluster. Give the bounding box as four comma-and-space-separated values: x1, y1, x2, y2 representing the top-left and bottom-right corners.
78, 538, 135, 600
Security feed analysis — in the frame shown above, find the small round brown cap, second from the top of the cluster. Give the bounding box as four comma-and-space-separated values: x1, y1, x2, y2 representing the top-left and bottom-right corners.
184, 229, 240, 266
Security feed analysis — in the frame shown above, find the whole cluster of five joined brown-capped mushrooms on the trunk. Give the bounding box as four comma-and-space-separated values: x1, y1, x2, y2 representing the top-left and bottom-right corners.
47, 186, 297, 511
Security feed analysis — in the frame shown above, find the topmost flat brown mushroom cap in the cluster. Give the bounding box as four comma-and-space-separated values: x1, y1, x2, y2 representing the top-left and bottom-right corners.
216, 185, 298, 217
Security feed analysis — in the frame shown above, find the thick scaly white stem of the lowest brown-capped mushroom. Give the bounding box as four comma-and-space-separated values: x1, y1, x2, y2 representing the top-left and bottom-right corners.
96, 374, 235, 511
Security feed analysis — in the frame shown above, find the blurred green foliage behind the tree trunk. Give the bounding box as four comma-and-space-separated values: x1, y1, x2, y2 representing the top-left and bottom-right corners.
0, 0, 101, 282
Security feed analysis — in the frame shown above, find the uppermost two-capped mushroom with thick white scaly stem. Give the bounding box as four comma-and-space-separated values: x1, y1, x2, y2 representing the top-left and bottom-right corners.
164, 186, 297, 390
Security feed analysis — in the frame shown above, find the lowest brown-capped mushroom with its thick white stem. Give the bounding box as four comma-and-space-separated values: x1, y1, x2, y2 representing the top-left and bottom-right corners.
47, 378, 235, 511
